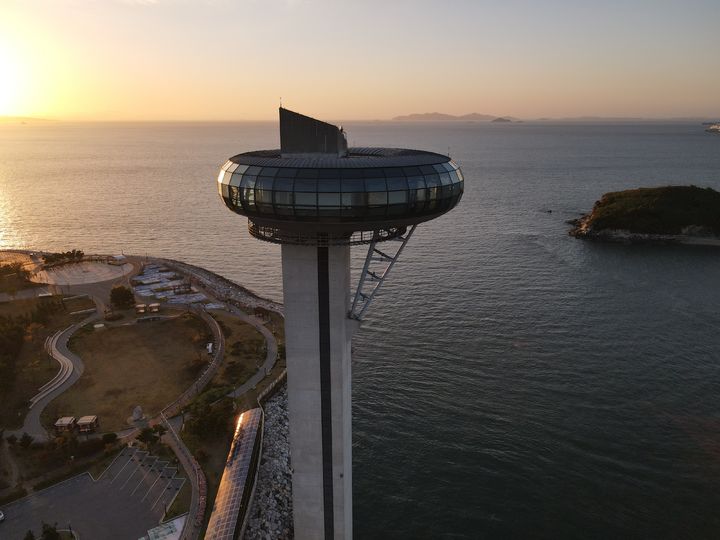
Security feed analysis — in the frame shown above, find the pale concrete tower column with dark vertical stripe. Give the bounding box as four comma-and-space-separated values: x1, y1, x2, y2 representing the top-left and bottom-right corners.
282, 245, 352, 540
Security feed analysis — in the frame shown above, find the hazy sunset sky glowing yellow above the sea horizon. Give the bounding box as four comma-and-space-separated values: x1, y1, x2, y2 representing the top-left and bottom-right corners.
0, 0, 720, 121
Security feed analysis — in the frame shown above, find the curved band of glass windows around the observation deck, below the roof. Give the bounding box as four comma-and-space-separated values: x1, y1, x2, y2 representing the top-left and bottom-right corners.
218, 158, 464, 222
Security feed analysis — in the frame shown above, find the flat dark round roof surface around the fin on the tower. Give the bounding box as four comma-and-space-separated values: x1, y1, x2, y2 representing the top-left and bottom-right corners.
230, 147, 450, 169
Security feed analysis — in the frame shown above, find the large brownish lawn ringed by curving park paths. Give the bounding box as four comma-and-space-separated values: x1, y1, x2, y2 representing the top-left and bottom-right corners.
43, 314, 209, 431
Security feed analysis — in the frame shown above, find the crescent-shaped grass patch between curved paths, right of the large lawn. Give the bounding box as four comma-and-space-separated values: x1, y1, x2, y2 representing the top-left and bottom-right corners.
211, 311, 266, 388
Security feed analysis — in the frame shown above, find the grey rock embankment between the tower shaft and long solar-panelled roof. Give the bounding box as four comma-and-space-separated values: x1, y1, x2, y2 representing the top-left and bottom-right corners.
244, 386, 294, 540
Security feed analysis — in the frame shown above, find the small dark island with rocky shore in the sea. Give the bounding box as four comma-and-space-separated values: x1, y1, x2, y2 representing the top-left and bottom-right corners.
568, 186, 720, 245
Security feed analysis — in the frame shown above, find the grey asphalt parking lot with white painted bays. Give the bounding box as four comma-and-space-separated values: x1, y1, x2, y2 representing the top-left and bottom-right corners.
0, 448, 185, 540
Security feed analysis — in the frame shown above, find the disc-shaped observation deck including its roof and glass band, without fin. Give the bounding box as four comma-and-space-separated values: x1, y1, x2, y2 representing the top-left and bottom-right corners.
218, 148, 464, 232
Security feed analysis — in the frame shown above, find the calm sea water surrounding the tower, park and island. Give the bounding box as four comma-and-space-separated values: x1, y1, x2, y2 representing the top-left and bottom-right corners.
0, 123, 720, 539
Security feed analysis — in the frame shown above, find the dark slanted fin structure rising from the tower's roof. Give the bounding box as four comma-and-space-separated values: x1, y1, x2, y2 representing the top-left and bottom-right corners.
280, 107, 347, 157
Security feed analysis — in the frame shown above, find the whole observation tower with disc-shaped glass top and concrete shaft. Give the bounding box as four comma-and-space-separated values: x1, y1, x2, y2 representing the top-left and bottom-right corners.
218, 107, 463, 540
